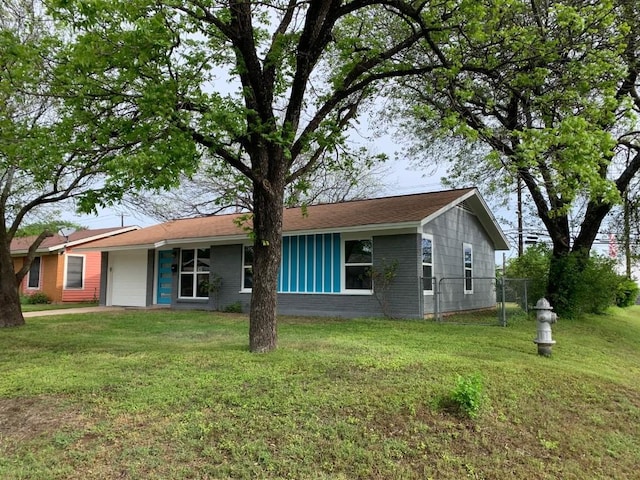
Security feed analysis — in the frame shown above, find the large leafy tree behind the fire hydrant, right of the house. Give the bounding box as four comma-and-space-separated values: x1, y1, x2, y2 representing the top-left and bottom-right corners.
392, 0, 640, 313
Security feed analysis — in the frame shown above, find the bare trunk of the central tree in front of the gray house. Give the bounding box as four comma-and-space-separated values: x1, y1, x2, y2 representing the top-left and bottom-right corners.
249, 178, 284, 353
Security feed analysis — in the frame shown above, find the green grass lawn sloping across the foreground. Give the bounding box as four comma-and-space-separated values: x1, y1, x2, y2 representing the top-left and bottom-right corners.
0, 307, 640, 480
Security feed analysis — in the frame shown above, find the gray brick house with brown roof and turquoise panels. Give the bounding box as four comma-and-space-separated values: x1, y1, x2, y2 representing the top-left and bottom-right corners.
83, 188, 509, 318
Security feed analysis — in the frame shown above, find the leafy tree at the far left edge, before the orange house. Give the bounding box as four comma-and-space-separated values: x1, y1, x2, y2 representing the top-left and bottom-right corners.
0, 0, 195, 327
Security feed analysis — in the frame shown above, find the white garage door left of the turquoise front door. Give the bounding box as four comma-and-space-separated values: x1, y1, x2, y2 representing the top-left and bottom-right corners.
107, 250, 147, 307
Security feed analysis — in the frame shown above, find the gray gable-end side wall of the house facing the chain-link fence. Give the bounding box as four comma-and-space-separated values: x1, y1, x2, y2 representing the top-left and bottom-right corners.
423, 207, 496, 314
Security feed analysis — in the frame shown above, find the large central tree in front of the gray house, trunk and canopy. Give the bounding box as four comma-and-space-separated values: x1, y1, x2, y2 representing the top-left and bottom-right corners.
52, 0, 443, 352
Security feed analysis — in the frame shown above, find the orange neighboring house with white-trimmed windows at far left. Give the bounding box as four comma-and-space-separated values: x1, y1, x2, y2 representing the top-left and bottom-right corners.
11, 227, 139, 303
